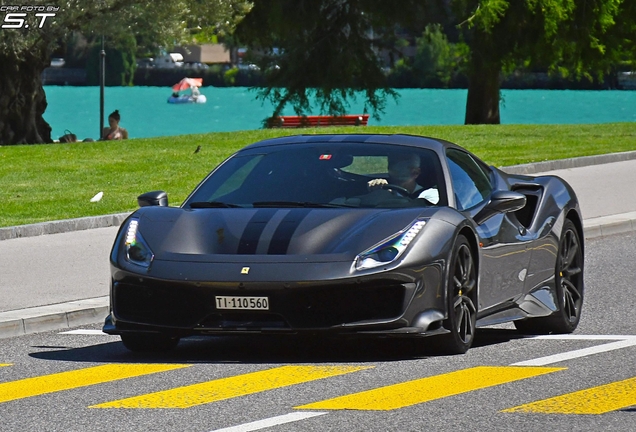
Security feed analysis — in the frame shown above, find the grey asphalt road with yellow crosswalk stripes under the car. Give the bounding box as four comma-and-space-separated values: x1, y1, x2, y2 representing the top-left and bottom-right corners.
0, 234, 636, 432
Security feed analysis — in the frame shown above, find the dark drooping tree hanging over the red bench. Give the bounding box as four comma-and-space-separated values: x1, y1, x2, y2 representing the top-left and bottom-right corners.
235, 0, 442, 117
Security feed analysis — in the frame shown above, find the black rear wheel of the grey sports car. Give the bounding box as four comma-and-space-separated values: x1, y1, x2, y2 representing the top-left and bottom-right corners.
514, 219, 584, 334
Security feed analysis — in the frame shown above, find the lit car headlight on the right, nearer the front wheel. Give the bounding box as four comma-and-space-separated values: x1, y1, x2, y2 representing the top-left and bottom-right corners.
355, 220, 426, 270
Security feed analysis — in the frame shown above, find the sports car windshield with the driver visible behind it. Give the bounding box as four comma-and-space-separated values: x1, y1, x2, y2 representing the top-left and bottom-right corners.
184, 143, 447, 208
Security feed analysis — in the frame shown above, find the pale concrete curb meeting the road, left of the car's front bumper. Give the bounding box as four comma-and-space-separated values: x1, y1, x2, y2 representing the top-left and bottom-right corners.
0, 296, 109, 339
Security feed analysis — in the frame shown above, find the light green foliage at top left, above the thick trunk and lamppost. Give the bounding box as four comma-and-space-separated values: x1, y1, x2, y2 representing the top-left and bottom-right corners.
0, 0, 250, 59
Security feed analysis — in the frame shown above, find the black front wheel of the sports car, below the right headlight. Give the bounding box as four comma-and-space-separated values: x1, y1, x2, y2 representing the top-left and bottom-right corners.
439, 235, 477, 354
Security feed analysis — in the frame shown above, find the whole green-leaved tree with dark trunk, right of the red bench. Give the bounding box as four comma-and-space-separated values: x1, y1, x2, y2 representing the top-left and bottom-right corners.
452, 0, 636, 124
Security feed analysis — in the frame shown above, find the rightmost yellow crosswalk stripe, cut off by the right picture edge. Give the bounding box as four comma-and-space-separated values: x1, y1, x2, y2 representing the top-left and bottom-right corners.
502, 378, 636, 414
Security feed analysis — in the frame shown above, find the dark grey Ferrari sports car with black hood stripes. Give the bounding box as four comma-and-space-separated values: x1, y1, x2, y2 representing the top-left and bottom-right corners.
103, 133, 584, 354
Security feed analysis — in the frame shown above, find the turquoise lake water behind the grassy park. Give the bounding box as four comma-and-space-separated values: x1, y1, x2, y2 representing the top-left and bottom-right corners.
44, 86, 636, 139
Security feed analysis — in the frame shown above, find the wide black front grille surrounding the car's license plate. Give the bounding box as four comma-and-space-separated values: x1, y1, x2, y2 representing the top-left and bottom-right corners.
113, 280, 406, 329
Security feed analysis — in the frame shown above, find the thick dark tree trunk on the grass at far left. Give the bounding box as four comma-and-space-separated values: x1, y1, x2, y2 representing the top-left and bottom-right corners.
0, 50, 52, 145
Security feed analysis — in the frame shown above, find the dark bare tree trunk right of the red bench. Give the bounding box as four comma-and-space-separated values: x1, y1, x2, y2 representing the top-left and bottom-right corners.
464, 37, 501, 124
